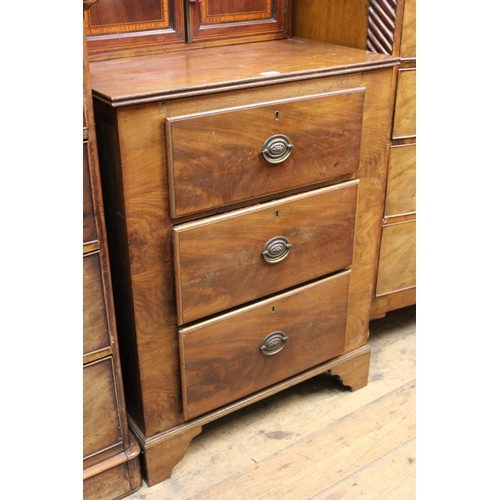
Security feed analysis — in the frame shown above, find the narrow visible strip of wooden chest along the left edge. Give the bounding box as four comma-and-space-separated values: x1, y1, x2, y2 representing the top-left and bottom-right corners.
83, 2, 142, 500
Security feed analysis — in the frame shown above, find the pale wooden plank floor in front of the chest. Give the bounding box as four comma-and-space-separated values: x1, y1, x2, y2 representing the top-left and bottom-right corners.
127, 306, 416, 500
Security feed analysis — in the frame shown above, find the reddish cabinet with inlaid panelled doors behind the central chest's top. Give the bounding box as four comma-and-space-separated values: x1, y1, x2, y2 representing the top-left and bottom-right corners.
85, 0, 291, 60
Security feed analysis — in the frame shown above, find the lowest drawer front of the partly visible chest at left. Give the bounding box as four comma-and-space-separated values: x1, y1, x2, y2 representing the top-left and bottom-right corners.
83, 358, 123, 466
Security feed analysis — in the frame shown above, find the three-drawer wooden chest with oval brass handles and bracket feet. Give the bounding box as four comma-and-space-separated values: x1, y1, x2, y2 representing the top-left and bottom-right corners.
90, 38, 398, 485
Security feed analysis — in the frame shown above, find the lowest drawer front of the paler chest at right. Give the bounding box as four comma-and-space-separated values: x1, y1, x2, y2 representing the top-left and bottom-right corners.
377, 220, 417, 296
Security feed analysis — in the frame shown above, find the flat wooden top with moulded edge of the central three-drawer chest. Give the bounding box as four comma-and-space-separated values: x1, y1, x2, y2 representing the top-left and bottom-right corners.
90, 38, 400, 106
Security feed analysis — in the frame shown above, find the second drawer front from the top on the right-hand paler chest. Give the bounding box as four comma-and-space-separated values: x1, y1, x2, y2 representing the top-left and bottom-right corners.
392, 69, 417, 139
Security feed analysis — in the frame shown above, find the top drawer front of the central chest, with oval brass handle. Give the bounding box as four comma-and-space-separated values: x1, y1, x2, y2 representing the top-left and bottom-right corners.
166, 89, 364, 217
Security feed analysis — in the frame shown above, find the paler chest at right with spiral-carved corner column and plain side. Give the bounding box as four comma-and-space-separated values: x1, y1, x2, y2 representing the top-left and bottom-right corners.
293, 0, 417, 318
